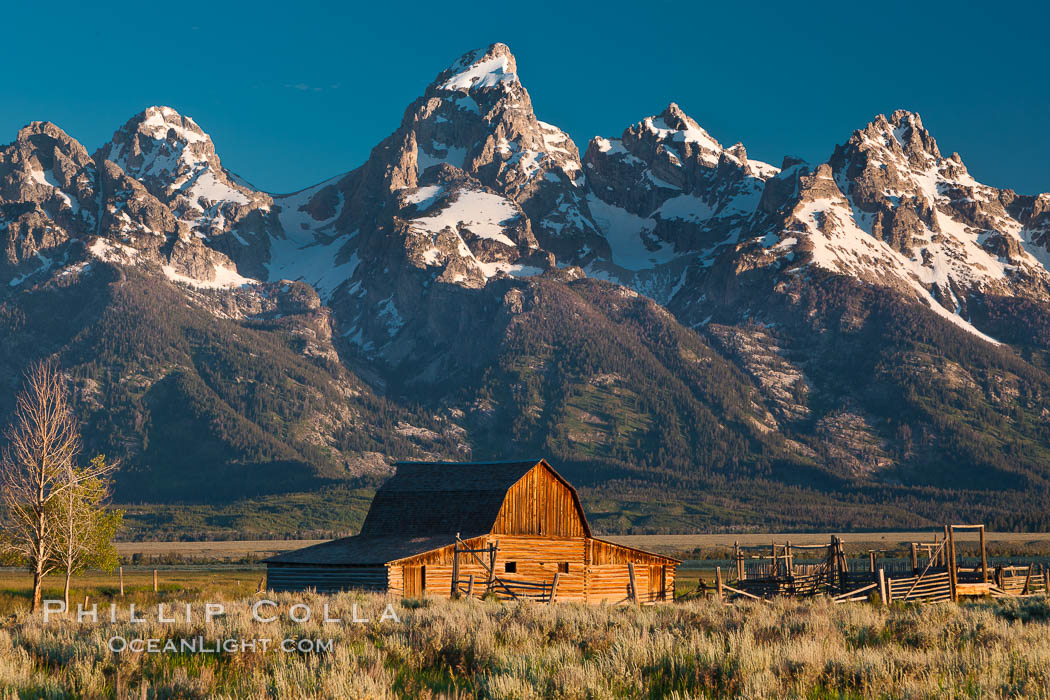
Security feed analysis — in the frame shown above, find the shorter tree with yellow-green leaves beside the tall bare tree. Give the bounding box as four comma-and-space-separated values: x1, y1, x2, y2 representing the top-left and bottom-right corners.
53, 454, 124, 610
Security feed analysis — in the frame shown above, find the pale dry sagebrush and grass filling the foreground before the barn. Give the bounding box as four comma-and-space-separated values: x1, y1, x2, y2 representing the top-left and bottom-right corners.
0, 593, 1050, 699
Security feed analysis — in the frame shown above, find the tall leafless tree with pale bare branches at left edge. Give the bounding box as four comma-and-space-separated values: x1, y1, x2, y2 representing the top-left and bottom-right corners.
0, 362, 110, 612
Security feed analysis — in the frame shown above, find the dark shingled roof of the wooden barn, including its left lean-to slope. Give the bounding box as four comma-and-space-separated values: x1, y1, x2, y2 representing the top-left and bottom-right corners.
266, 460, 589, 566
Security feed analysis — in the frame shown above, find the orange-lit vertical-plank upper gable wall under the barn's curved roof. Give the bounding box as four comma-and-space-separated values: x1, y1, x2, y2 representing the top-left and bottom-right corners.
492, 465, 586, 537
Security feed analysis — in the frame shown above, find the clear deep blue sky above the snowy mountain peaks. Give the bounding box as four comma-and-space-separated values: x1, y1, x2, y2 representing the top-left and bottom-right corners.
0, 0, 1050, 193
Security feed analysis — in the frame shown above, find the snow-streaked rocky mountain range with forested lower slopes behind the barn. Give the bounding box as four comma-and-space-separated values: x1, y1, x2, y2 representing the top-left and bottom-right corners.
0, 44, 1050, 536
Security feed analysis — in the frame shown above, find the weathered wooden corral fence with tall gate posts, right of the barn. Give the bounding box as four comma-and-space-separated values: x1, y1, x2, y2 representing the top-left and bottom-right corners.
714, 525, 1050, 604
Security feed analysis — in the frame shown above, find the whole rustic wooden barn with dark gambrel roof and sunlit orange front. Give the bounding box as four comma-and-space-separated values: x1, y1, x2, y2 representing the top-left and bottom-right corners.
266, 460, 679, 603
